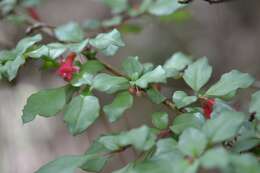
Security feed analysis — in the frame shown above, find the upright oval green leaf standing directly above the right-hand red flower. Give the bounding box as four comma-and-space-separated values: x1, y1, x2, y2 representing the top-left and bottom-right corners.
183, 57, 212, 91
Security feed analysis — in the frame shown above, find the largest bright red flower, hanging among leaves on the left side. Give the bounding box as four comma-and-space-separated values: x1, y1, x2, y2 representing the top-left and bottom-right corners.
58, 52, 79, 81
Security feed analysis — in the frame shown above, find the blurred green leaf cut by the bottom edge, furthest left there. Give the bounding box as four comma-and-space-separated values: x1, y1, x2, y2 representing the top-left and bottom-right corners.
35, 156, 85, 173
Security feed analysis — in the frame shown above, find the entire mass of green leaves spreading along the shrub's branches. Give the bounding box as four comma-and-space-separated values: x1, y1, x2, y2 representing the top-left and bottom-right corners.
0, 0, 260, 173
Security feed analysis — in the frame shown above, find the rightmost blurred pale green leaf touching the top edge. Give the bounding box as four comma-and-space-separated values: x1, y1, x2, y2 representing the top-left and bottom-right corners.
149, 0, 185, 16
